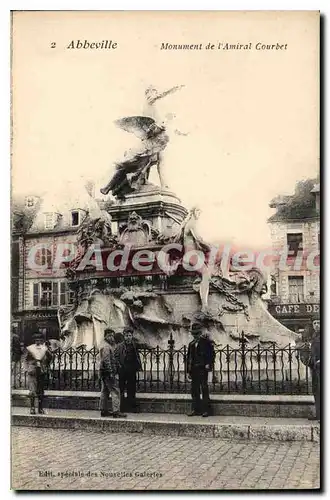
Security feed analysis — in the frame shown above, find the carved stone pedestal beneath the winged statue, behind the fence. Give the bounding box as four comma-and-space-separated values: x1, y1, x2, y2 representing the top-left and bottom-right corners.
62, 184, 296, 349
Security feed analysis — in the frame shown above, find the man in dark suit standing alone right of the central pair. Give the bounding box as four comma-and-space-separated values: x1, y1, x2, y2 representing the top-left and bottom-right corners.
187, 322, 214, 417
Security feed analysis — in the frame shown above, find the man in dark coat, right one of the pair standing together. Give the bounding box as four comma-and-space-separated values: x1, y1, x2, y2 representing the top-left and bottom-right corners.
115, 327, 142, 412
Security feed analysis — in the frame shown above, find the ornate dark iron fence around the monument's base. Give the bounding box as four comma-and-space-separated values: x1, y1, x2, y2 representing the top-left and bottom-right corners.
12, 335, 312, 394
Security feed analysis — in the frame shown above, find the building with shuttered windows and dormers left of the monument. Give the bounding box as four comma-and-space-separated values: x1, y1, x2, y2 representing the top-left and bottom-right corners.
11, 182, 100, 344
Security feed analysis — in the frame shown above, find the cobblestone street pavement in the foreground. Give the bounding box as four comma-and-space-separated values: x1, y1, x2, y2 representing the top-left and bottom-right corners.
12, 427, 320, 490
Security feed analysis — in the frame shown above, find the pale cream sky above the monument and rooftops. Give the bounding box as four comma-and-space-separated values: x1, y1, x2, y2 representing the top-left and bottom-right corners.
12, 12, 319, 247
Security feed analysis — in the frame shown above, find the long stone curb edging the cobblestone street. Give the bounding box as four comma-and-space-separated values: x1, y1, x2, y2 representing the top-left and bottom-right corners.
12, 415, 320, 442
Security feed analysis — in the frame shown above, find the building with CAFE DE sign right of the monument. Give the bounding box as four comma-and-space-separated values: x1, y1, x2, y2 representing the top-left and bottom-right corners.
268, 180, 320, 333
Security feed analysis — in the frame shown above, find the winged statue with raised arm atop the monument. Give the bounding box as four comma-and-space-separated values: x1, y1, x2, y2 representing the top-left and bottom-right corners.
101, 85, 184, 199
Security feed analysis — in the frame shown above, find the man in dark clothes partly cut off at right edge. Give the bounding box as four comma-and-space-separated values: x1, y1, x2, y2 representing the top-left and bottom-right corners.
309, 318, 321, 420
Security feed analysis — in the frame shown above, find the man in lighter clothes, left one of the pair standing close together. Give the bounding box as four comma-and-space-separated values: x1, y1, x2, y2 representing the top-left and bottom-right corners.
100, 329, 127, 418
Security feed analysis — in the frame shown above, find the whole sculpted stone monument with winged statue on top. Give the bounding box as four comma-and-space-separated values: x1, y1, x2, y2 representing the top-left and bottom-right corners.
59, 87, 297, 349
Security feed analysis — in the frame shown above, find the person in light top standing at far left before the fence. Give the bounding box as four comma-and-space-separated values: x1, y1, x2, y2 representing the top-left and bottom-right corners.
23, 332, 52, 415
